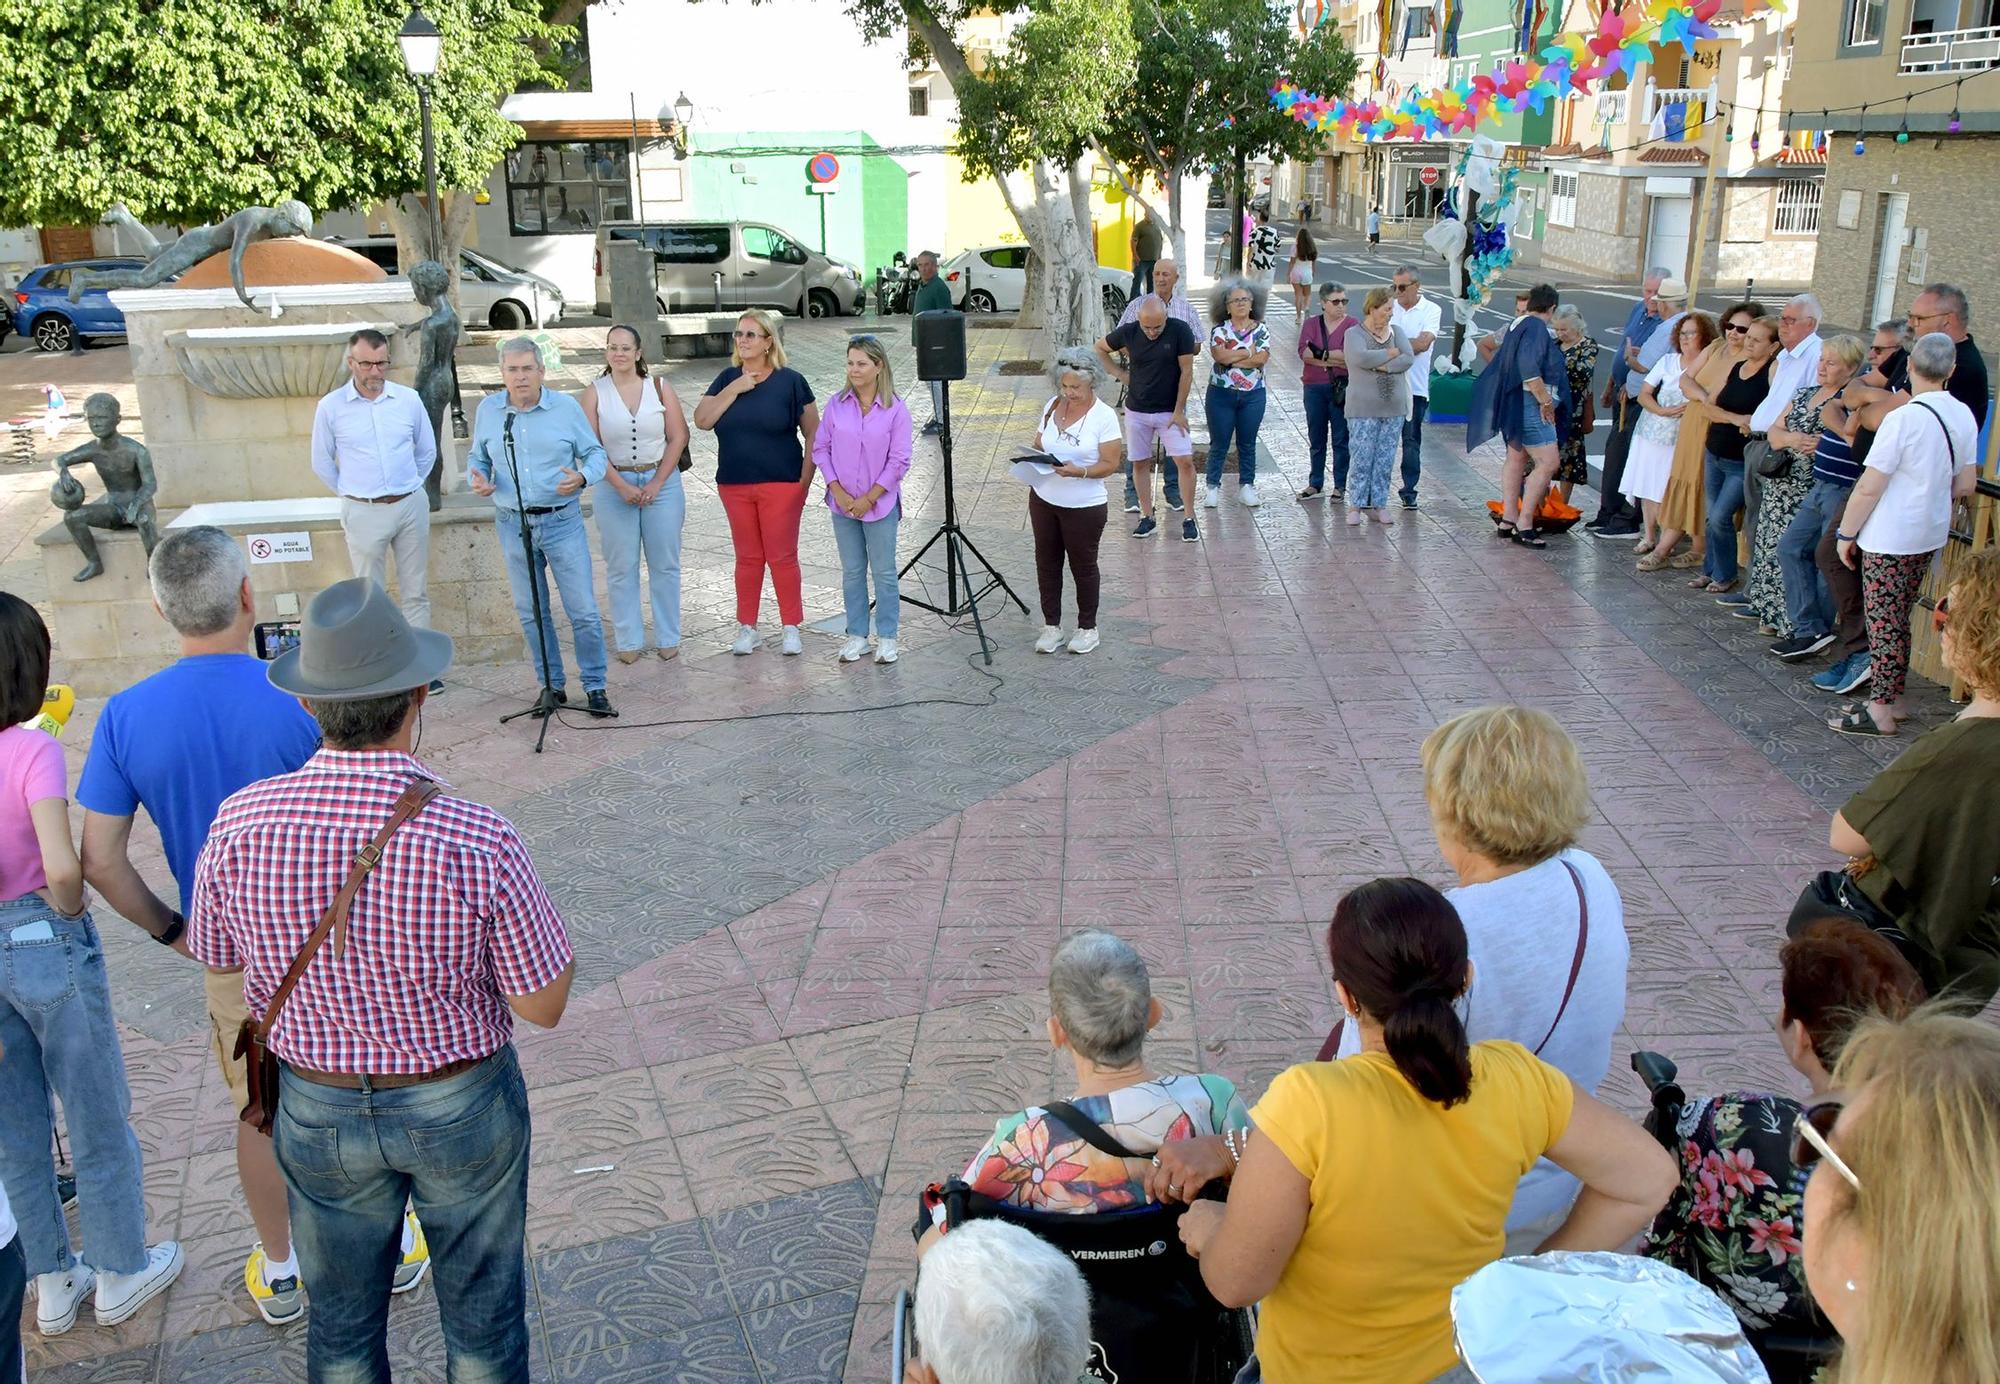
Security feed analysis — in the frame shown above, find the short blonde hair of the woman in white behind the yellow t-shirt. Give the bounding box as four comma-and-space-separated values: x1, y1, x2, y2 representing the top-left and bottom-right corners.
1424, 706, 1590, 864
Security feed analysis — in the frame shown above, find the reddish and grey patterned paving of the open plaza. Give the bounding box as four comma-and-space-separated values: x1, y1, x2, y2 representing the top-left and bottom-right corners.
28, 308, 1948, 1384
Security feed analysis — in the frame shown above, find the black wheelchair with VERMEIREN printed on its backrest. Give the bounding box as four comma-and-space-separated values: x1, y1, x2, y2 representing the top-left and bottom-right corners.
892, 1178, 1256, 1384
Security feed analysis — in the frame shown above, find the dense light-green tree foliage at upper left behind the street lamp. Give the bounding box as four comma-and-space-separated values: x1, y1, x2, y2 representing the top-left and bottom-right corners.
0, 0, 566, 284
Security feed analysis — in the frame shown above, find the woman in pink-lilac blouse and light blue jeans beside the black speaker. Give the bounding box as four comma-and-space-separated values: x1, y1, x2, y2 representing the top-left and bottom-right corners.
812, 336, 910, 664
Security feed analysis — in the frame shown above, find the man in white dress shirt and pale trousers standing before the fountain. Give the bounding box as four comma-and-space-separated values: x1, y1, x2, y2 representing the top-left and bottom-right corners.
312, 328, 442, 692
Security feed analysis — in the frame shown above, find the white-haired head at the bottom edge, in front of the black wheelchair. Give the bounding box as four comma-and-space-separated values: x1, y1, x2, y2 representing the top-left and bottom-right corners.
902, 1220, 1090, 1384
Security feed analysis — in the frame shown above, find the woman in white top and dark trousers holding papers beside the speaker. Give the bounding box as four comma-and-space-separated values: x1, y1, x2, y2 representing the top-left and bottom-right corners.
1016, 346, 1124, 654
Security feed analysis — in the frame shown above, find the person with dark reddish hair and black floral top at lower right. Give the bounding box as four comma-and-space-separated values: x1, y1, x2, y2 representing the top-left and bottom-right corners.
1646, 916, 1926, 1342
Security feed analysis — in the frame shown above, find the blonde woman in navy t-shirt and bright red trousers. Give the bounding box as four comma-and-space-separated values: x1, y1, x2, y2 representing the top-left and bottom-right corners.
694, 308, 820, 654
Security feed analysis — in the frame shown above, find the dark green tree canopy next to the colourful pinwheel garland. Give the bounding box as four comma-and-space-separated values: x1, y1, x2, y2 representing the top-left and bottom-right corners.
1092, 0, 1358, 274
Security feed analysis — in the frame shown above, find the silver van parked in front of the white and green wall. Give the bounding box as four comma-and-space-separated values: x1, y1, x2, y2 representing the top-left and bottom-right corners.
594, 220, 864, 318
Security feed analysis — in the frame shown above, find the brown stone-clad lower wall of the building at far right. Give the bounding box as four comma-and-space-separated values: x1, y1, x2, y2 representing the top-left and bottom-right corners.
1812, 134, 2000, 336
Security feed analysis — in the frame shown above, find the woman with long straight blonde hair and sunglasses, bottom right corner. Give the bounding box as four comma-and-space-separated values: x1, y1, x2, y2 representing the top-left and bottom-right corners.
1792, 1006, 2000, 1384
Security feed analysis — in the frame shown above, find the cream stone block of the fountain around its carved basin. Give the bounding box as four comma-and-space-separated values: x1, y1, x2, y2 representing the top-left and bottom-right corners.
114, 282, 424, 510
